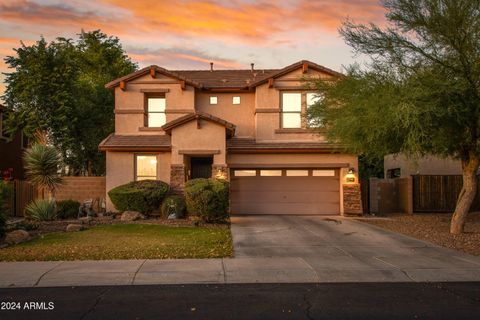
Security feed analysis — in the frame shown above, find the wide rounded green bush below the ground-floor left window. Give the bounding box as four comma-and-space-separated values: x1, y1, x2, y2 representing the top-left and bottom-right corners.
108, 180, 169, 214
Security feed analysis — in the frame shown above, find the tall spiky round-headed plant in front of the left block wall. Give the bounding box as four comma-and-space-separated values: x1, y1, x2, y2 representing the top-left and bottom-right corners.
23, 144, 62, 196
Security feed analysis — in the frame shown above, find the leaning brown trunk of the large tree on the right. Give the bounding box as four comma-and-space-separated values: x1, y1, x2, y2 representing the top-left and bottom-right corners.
450, 152, 480, 234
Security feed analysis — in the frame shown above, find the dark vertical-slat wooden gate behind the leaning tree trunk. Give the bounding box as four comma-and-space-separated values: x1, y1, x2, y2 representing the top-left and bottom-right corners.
412, 175, 480, 212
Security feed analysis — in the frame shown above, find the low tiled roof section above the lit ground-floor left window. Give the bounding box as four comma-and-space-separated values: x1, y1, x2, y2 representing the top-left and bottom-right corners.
99, 133, 171, 150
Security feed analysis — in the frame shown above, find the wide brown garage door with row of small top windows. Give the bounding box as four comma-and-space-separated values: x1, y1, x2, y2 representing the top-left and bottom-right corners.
230, 169, 340, 215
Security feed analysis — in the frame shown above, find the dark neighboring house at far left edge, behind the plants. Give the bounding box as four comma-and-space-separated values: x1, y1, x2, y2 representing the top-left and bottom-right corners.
0, 105, 28, 179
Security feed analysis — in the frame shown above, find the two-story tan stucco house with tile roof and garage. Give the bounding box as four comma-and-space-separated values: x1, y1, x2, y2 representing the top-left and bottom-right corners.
100, 61, 362, 214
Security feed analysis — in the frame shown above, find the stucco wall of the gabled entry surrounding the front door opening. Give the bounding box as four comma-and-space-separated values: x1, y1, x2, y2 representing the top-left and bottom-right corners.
171, 120, 226, 165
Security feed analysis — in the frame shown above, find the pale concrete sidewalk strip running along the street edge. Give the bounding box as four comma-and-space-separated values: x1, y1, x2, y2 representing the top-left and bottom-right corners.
0, 257, 480, 288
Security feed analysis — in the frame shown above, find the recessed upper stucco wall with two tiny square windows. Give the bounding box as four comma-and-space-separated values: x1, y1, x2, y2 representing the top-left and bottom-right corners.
195, 91, 255, 138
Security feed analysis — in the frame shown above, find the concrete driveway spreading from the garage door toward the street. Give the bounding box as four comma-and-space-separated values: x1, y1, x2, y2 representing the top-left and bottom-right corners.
232, 216, 480, 282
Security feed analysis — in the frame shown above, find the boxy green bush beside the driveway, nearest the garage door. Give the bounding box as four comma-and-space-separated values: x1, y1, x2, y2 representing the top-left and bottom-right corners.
185, 179, 229, 222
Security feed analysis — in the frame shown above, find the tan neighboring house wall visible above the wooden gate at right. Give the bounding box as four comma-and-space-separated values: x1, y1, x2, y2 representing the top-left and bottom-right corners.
383, 154, 462, 179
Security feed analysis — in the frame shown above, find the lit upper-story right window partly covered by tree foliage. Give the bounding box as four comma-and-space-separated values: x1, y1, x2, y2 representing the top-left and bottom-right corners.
281, 92, 321, 129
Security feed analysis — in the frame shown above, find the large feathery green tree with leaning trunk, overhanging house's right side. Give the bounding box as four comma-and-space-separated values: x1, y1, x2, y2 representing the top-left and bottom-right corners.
308, 0, 480, 234
